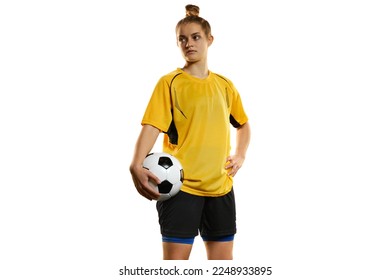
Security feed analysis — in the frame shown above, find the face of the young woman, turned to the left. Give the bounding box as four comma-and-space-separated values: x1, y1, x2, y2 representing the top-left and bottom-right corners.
176, 23, 213, 63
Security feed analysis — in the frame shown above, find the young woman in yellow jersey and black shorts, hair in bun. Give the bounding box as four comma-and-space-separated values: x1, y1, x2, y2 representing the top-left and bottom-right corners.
130, 5, 250, 260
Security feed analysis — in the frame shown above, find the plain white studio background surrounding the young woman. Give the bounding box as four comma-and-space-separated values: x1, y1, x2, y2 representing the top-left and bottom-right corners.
0, 0, 390, 280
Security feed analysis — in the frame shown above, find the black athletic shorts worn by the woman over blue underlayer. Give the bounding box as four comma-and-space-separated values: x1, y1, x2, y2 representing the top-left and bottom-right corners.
156, 189, 237, 238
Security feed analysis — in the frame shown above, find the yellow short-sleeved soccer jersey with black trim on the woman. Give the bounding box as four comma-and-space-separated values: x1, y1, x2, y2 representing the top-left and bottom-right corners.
142, 69, 248, 196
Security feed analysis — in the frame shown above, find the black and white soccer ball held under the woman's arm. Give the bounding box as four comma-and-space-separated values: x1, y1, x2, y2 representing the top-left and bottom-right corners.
143, 153, 183, 201
